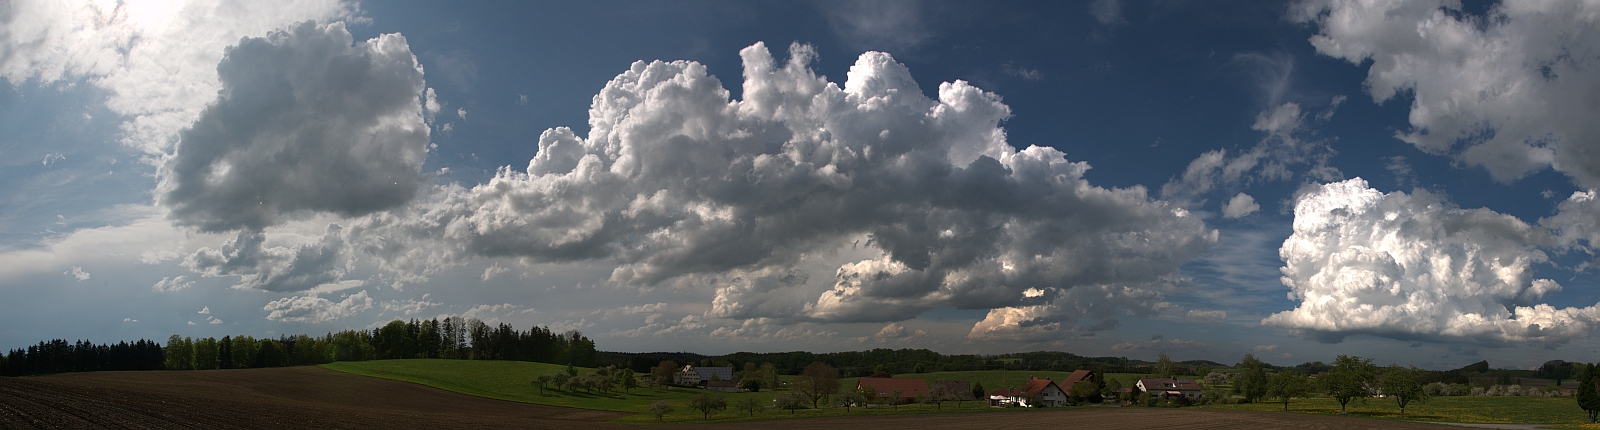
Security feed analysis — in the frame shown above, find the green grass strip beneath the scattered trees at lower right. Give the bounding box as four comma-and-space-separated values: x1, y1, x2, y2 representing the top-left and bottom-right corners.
1195, 396, 1587, 428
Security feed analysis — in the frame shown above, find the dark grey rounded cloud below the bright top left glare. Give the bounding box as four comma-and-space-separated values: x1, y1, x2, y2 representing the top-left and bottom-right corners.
158, 22, 429, 232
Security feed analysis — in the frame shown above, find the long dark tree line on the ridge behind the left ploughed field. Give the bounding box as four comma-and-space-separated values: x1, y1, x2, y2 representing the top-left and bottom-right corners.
0, 317, 598, 376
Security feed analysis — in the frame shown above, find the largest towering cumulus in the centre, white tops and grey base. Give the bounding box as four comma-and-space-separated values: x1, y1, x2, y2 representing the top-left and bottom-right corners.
350, 43, 1216, 321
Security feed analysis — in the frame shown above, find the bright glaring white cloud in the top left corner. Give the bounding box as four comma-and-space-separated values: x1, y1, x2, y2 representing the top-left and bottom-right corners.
0, 0, 358, 155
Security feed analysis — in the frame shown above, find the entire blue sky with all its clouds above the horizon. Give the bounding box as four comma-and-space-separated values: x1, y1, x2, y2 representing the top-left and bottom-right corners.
0, 0, 1600, 369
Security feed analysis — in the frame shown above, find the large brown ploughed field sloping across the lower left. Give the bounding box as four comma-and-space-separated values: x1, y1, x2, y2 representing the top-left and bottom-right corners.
0, 366, 626, 428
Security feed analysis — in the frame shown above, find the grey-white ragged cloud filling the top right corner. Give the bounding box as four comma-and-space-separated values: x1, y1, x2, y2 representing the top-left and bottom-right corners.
1290, 0, 1600, 189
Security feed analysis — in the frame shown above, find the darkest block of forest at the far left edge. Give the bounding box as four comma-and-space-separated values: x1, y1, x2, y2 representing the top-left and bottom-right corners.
0, 339, 165, 376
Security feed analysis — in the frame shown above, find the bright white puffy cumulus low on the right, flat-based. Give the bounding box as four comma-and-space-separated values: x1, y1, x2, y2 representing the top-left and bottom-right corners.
1262, 179, 1600, 345
